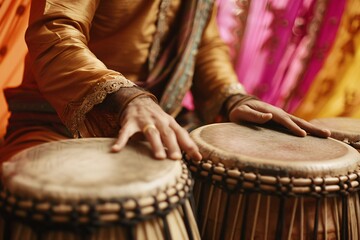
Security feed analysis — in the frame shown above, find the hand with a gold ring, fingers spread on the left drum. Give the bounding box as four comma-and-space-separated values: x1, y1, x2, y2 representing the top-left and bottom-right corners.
112, 97, 202, 161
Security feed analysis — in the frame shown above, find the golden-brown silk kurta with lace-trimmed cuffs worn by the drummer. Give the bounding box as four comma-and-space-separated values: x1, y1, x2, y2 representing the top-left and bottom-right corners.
4, 0, 244, 143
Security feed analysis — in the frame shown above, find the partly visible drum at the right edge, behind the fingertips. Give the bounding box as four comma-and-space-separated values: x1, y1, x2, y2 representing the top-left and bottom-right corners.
310, 117, 360, 152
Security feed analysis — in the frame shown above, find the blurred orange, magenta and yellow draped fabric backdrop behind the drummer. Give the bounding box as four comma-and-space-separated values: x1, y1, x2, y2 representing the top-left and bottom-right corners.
0, 0, 360, 140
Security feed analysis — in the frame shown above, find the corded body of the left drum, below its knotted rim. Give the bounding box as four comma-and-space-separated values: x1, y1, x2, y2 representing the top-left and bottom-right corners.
0, 200, 200, 240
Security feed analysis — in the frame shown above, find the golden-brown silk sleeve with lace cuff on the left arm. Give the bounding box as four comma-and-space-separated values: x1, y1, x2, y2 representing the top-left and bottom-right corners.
25, 0, 134, 137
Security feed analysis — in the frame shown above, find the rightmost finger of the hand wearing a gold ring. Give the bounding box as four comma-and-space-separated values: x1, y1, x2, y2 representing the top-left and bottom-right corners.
171, 122, 202, 161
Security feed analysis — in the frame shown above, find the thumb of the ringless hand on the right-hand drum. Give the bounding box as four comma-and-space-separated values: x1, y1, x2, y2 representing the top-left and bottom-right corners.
229, 105, 273, 124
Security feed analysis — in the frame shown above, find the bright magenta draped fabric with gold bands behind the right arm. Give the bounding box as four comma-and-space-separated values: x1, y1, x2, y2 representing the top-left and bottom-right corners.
217, 0, 346, 112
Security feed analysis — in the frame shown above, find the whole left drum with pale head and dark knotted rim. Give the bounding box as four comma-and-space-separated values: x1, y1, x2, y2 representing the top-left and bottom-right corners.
0, 138, 200, 240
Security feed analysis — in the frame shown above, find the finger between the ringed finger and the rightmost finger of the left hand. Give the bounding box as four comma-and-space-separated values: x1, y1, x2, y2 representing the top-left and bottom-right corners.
159, 126, 182, 160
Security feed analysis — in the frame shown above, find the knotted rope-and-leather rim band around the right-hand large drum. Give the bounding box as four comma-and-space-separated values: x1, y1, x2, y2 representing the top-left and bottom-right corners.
185, 156, 360, 196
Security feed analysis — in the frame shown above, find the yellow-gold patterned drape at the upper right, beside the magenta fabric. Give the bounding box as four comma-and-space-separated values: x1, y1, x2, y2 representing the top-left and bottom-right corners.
294, 0, 360, 119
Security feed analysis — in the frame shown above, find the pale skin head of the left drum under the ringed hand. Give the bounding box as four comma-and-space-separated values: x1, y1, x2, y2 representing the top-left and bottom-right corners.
3, 138, 182, 201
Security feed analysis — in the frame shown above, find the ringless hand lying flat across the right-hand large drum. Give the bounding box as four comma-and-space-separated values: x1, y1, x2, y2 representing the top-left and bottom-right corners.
229, 99, 330, 138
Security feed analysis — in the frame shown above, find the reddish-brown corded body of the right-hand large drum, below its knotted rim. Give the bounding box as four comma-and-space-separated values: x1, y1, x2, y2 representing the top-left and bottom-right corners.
194, 182, 360, 240
